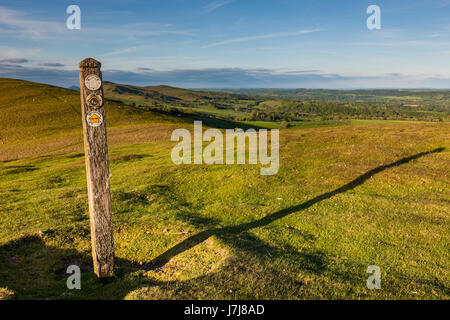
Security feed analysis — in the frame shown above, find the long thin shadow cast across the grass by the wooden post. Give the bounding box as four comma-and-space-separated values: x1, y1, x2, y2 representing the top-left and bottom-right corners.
147, 148, 445, 270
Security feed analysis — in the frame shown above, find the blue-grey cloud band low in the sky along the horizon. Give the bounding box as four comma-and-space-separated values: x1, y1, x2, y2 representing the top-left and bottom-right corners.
0, 59, 450, 89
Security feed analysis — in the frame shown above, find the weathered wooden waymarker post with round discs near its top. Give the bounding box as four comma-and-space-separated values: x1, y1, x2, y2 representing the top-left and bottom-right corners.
79, 58, 114, 279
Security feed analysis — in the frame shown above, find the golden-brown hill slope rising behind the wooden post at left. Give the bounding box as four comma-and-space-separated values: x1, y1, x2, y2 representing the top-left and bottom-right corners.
0, 78, 187, 160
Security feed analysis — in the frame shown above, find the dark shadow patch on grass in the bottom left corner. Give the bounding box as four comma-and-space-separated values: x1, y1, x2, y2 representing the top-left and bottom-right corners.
0, 235, 142, 300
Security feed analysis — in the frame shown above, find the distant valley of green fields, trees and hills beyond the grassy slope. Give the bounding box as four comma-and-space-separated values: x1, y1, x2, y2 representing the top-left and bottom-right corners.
101, 82, 450, 125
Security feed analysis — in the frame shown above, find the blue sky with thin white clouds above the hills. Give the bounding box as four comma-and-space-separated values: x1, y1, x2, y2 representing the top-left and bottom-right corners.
0, 0, 450, 89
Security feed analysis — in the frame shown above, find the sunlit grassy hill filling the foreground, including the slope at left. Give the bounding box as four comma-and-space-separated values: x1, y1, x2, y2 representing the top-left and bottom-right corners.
0, 80, 450, 299
